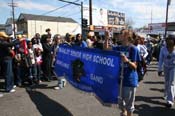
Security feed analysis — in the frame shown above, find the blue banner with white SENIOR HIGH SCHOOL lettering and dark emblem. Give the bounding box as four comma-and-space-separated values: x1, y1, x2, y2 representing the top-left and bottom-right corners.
55, 45, 120, 103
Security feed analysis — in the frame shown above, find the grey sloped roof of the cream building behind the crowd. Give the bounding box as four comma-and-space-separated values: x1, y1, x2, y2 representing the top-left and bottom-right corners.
18, 13, 77, 23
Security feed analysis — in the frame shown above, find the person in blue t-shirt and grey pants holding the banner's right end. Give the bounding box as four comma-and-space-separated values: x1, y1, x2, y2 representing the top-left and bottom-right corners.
105, 30, 140, 116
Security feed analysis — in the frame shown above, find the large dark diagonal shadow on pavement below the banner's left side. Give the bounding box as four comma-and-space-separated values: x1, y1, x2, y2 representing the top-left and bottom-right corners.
26, 89, 73, 116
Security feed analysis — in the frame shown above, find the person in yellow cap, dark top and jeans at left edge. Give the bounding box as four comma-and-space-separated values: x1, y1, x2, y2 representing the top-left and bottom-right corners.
0, 32, 19, 92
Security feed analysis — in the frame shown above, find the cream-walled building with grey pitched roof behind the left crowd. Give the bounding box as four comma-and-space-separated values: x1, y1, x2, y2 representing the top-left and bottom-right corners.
17, 14, 81, 38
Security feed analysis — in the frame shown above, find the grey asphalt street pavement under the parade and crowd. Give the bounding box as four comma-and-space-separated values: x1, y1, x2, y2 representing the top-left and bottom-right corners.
0, 62, 175, 116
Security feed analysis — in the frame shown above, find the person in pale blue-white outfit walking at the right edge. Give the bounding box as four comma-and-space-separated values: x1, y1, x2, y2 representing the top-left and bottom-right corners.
158, 35, 175, 108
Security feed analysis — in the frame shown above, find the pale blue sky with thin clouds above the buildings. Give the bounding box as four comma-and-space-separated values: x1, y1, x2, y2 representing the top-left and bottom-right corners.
0, 0, 175, 27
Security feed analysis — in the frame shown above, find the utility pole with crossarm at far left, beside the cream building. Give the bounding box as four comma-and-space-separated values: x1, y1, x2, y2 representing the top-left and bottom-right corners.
9, 0, 17, 38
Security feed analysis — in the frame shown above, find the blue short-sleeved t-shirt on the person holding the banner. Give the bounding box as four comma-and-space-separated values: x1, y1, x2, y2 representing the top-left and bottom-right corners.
114, 46, 140, 87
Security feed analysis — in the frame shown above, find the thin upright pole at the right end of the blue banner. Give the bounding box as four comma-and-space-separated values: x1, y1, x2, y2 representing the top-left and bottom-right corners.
118, 61, 124, 107
